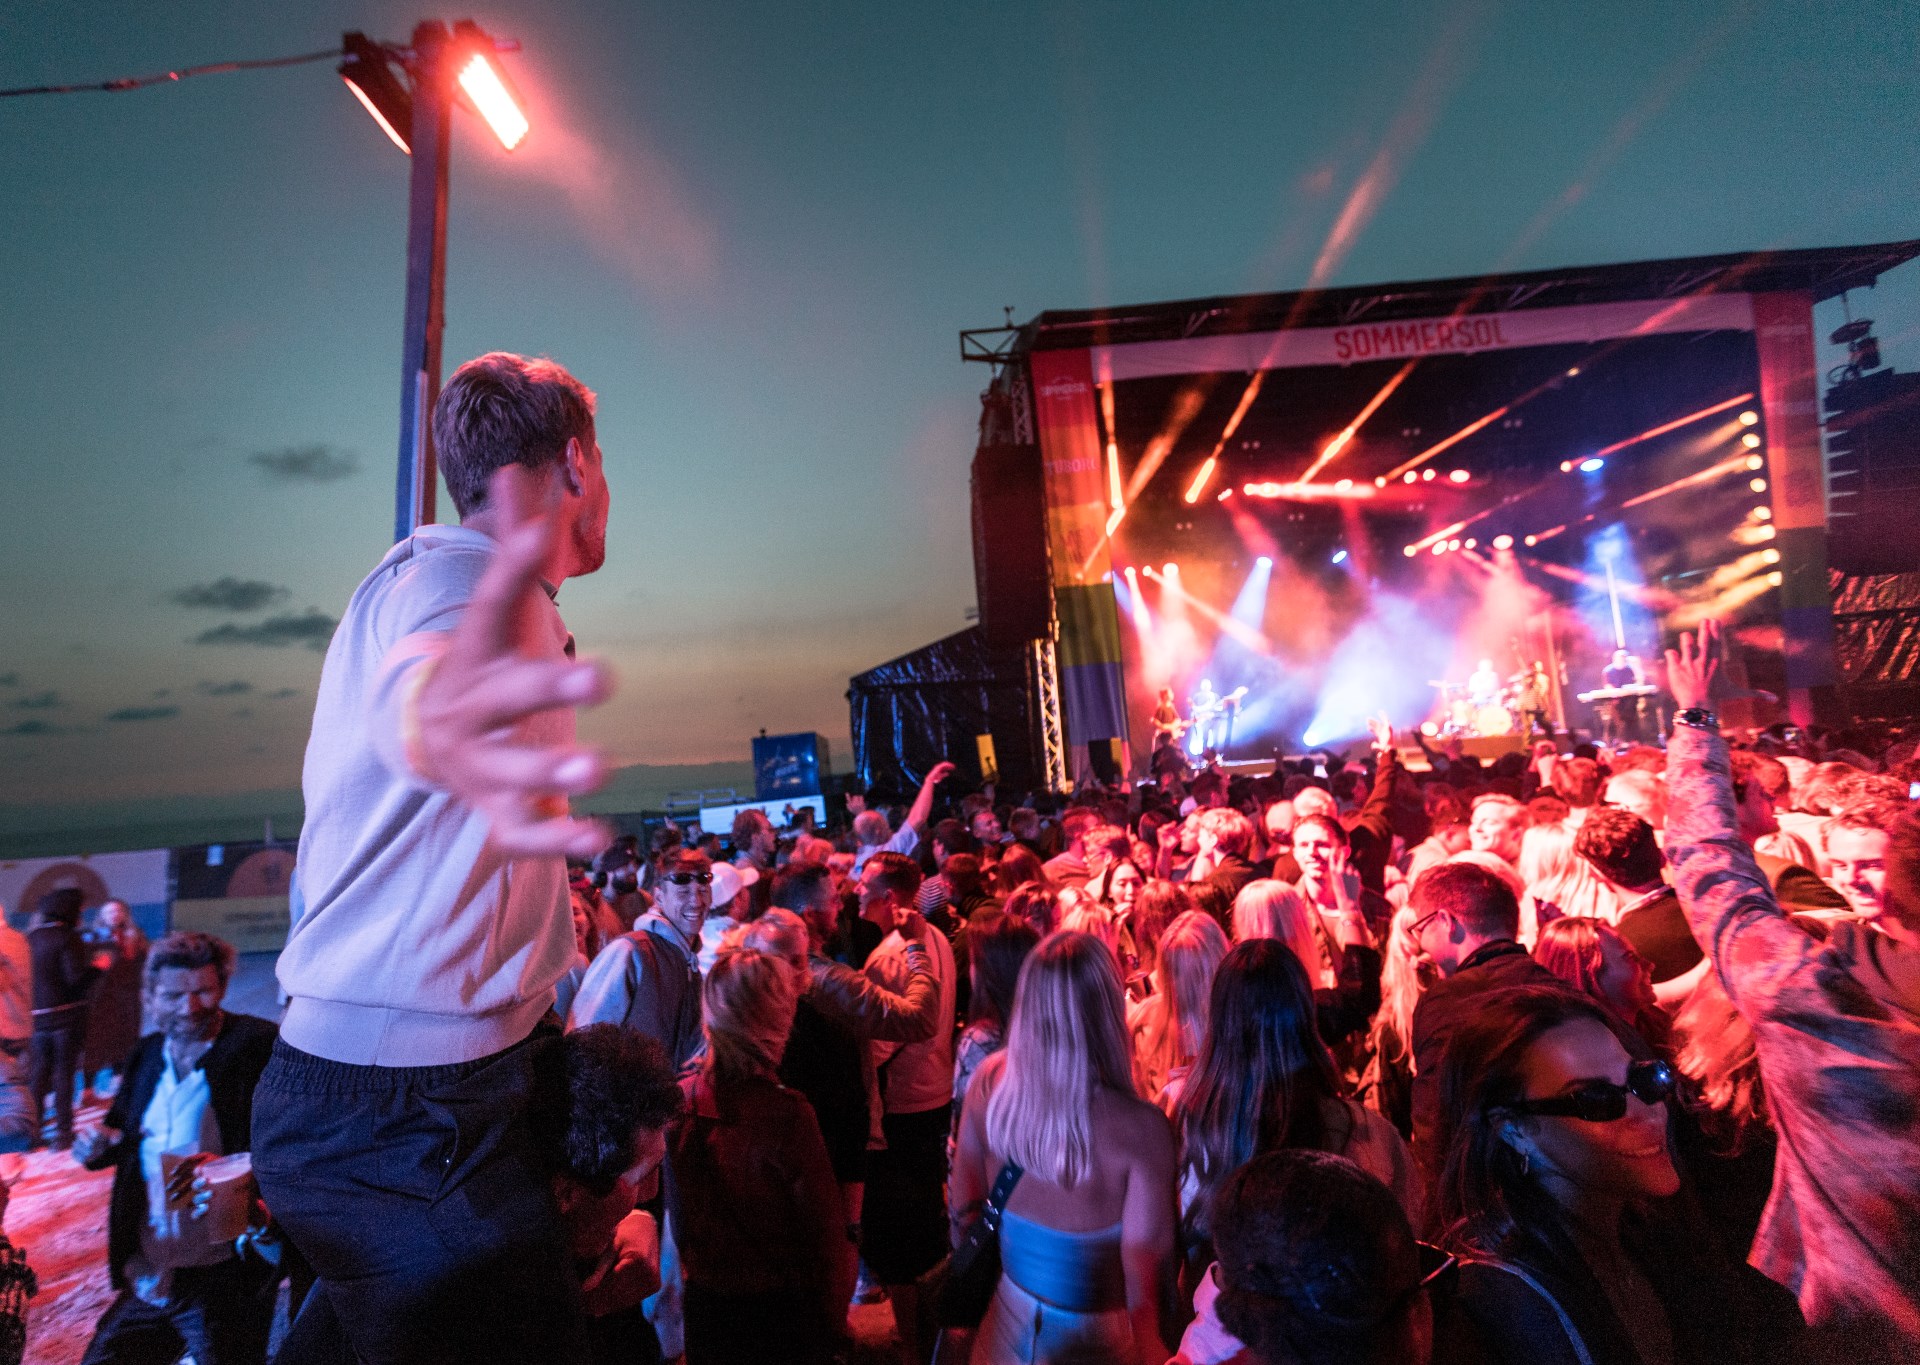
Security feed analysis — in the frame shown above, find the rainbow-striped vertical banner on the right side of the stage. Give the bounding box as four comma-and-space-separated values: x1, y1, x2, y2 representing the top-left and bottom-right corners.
1753, 290, 1837, 726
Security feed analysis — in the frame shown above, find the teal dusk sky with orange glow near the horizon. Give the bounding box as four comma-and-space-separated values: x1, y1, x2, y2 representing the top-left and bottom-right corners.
0, 0, 1920, 829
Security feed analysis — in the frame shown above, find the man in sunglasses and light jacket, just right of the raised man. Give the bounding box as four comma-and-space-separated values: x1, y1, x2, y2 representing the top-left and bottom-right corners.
566, 849, 714, 1069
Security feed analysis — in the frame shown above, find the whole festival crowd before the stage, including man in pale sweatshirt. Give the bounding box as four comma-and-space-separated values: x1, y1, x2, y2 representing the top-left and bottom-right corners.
3, 355, 1920, 1365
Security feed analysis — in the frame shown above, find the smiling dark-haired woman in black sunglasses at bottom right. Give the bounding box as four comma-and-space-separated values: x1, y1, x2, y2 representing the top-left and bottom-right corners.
1428, 987, 1797, 1365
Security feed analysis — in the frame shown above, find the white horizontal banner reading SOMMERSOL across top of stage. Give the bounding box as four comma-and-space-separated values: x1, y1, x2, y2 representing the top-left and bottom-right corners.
1092, 294, 1753, 382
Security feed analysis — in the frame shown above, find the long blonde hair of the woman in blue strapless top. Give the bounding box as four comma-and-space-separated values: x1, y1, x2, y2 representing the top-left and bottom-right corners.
987, 929, 1135, 1188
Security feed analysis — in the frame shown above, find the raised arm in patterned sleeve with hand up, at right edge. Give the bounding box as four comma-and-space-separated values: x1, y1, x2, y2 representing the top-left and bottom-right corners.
1667, 726, 1920, 1361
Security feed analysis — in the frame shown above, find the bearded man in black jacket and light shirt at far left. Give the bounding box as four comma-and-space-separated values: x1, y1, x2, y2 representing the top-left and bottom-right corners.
75, 933, 280, 1365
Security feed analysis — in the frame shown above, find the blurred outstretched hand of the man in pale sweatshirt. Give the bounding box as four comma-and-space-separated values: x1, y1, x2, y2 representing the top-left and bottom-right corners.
407, 465, 612, 858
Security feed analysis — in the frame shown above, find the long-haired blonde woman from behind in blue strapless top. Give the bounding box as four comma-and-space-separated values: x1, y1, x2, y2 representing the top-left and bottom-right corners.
948, 931, 1175, 1365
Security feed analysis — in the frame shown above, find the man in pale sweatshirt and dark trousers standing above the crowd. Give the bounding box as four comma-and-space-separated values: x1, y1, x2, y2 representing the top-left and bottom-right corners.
253, 353, 611, 1365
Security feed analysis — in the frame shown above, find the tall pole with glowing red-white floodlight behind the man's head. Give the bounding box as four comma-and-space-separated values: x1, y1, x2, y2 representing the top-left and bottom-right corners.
340, 19, 532, 541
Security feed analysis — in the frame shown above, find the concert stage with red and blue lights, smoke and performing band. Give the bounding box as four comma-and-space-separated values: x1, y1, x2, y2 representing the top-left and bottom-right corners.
854, 242, 1920, 787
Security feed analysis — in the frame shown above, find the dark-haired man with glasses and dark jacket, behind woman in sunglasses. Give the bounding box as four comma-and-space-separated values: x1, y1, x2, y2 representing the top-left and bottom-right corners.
1407, 862, 1565, 1188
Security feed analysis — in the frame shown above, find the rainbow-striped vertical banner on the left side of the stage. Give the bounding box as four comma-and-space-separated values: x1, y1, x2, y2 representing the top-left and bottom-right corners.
1027, 349, 1127, 745
